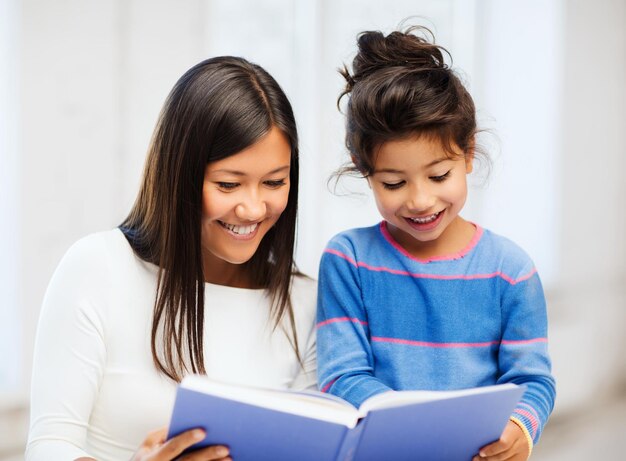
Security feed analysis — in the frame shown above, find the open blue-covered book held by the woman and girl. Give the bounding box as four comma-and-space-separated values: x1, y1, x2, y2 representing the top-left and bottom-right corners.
168, 376, 524, 461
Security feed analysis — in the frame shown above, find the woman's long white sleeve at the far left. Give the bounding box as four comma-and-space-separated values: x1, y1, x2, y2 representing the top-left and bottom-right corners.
26, 239, 108, 461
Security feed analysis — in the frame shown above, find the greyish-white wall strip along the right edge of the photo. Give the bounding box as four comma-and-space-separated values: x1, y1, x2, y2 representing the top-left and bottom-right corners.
550, 0, 626, 410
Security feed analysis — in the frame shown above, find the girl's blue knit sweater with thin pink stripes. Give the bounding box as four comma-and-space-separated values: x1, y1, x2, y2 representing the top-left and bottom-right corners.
317, 221, 555, 447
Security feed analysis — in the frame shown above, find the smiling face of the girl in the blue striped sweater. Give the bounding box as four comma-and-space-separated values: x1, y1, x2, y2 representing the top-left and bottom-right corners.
368, 136, 473, 257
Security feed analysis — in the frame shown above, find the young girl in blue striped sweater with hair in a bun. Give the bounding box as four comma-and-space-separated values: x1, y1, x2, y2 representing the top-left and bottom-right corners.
317, 28, 555, 460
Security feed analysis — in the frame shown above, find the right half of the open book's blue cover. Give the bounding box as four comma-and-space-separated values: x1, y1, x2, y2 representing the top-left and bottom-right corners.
354, 384, 525, 461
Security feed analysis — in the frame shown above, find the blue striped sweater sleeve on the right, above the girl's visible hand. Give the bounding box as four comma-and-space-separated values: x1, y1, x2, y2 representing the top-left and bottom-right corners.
498, 267, 556, 448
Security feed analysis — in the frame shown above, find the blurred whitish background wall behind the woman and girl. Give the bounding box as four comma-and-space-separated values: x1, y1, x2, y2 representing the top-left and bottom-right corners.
0, 0, 626, 459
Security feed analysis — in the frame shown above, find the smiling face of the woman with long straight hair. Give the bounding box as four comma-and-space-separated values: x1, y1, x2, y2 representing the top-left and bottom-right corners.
201, 127, 291, 285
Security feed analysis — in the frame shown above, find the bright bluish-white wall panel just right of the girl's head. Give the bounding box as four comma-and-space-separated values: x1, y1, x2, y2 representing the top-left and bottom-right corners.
470, 0, 565, 286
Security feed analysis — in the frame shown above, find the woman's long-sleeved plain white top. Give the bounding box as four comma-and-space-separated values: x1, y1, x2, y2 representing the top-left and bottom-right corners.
26, 229, 316, 461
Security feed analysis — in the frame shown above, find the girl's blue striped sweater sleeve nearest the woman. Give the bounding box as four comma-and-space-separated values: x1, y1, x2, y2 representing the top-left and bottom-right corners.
317, 241, 391, 407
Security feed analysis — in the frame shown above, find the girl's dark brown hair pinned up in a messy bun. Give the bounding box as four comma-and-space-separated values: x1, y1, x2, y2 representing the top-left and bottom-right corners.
337, 26, 478, 177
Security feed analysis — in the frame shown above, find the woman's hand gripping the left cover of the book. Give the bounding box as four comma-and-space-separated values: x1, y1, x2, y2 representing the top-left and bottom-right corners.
131, 428, 231, 461
